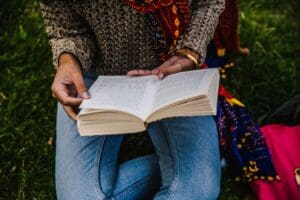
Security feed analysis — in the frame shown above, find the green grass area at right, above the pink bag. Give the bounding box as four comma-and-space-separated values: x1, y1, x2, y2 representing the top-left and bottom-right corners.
227, 0, 300, 118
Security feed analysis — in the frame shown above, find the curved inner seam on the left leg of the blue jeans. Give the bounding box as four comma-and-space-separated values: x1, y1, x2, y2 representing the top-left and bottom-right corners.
94, 136, 106, 199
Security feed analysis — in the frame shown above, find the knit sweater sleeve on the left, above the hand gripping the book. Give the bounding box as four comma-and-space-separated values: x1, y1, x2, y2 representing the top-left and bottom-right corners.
40, 0, 95, 70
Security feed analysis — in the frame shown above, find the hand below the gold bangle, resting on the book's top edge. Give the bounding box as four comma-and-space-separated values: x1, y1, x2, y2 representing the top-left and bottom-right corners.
127, 56, 194, 79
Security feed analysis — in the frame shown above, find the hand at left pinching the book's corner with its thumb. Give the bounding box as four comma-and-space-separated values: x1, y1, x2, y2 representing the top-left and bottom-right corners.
51, 54, 90, 121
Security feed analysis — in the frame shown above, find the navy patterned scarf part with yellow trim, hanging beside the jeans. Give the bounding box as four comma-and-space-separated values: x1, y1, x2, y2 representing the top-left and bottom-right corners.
201, 41, 279, 182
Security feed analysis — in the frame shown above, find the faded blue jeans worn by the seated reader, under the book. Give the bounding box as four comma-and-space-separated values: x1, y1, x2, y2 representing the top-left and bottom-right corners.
55, 71, 220, 200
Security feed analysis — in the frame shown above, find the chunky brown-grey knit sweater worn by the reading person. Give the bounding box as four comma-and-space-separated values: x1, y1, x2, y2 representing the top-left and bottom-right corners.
40, 0, 224, 75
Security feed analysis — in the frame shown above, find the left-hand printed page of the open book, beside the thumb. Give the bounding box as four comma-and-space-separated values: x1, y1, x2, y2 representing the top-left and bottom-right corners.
80, 76, 158, 120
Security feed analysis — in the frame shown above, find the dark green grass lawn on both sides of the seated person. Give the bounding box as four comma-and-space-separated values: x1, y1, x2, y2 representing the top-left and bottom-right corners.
0, 0, 300, 200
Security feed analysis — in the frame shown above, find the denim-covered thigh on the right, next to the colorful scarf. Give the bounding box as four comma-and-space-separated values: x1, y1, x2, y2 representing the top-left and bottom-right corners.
149, 116, 220, 199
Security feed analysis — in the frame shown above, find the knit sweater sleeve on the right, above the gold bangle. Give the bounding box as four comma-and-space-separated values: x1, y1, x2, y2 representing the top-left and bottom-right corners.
175, 0, 225, 63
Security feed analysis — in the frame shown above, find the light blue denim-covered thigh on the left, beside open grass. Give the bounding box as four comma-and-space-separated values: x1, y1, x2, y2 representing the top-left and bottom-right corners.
55, 72, 122, 200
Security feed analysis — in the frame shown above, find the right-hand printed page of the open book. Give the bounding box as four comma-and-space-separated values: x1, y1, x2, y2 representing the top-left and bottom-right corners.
153, 69, 218, 111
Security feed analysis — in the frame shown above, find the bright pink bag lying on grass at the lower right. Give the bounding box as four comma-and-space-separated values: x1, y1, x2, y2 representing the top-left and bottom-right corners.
251, 124, 300, 200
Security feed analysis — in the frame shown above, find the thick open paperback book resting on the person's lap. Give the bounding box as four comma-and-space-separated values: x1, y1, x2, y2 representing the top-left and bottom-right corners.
77, 69, 219, 135
